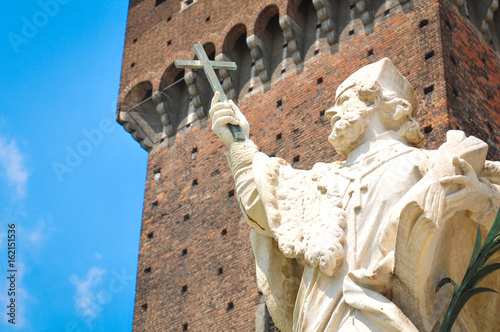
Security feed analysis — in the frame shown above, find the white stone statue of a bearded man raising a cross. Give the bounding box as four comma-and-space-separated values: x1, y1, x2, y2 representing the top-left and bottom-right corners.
210, 58, 500, 332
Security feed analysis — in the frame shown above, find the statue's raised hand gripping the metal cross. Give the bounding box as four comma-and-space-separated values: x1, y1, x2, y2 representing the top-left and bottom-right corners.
209, 92, 250, 147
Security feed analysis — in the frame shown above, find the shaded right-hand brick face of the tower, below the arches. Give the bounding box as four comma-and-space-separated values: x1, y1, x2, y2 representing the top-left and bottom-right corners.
440, 1, 500, 160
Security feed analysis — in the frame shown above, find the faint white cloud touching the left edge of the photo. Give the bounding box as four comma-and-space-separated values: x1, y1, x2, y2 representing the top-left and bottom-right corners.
0, 136, 28, 197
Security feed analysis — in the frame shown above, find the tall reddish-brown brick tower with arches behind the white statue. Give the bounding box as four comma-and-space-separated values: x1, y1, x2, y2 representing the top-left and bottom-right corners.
117, 0, 500, 331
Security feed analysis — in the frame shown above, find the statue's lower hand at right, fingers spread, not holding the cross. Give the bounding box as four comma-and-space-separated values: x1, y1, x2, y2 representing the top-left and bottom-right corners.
440, 157, 490, 215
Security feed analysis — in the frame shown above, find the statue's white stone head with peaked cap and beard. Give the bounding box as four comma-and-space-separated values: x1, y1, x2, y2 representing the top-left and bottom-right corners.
325, 58, 424, 157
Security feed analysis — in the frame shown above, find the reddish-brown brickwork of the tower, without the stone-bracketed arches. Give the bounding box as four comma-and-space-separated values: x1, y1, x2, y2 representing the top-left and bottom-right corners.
119, 0, 499, 331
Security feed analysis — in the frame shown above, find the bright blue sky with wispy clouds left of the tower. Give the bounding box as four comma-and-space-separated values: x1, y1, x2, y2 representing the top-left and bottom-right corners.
0, 0, 147, 331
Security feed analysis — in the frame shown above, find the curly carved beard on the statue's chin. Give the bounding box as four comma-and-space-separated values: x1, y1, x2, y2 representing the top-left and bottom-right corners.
328, 109, 367, 158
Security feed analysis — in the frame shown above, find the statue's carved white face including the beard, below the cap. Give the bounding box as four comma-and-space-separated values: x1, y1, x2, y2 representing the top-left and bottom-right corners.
325, 88, 369, 157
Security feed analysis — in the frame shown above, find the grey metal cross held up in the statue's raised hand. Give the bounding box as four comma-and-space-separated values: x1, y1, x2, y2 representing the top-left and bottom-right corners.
174, 44, 245, 141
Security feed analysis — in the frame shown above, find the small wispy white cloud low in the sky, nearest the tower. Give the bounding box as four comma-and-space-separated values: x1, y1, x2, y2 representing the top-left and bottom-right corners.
70, 267, 106, 319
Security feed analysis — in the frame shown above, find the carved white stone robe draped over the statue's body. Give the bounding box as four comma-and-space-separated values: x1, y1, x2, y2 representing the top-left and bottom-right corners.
231, 132, 499, 332
